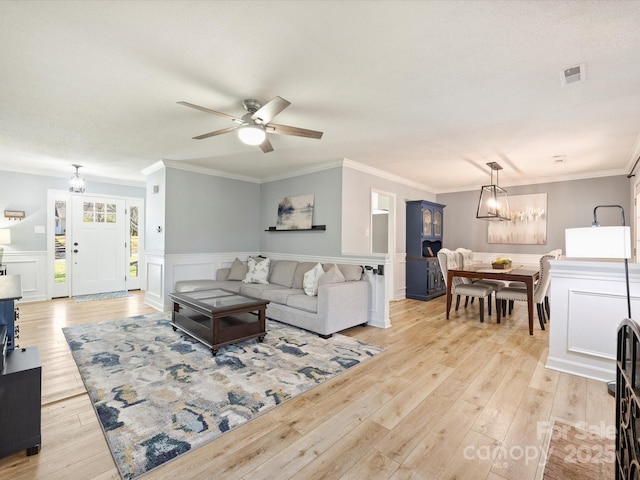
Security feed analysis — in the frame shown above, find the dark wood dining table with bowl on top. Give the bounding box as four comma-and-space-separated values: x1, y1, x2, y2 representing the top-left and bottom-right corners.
447, 263, 540, 335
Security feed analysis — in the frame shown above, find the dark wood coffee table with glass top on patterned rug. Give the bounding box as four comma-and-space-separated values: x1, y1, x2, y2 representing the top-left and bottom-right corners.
169, 288, 269, 355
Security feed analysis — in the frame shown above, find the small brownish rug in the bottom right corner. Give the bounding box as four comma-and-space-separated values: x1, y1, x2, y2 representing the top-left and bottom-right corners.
543, 420, 616, 480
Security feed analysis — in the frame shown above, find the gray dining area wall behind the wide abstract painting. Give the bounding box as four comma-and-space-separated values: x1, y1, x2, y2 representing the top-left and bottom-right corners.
437, 175, 633, 254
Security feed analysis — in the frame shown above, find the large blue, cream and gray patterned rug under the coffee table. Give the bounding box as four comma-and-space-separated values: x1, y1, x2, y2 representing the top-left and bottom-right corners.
63, 313, 383, 480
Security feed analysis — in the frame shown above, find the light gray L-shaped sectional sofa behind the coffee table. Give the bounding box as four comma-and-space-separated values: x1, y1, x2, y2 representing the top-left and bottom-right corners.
175, 259, 370, 338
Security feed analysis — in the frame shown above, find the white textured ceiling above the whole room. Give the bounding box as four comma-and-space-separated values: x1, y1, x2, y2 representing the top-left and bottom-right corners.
0, 0, 640, 192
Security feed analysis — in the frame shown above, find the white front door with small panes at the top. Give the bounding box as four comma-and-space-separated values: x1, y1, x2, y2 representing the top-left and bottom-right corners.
72, 195, 128, 296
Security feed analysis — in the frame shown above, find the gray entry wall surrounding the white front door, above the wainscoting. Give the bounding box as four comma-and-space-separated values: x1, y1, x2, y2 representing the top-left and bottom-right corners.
0, 166, 145, 252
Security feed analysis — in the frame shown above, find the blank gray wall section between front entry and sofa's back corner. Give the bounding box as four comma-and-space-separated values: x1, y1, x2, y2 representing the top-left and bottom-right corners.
164, 168, 261, 254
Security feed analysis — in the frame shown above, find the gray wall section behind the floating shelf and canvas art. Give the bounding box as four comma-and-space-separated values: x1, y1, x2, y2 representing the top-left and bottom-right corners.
260, 167, 342, 256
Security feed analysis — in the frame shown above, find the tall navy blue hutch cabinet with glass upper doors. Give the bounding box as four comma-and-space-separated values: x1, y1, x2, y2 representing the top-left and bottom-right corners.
406, 200, 447, 300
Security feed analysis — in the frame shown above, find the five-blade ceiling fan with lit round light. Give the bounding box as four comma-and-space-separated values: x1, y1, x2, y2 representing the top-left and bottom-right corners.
178, 97, 323, 153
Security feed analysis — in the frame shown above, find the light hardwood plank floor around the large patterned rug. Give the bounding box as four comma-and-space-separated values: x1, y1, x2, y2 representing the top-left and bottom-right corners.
0, 292, 615, 480
